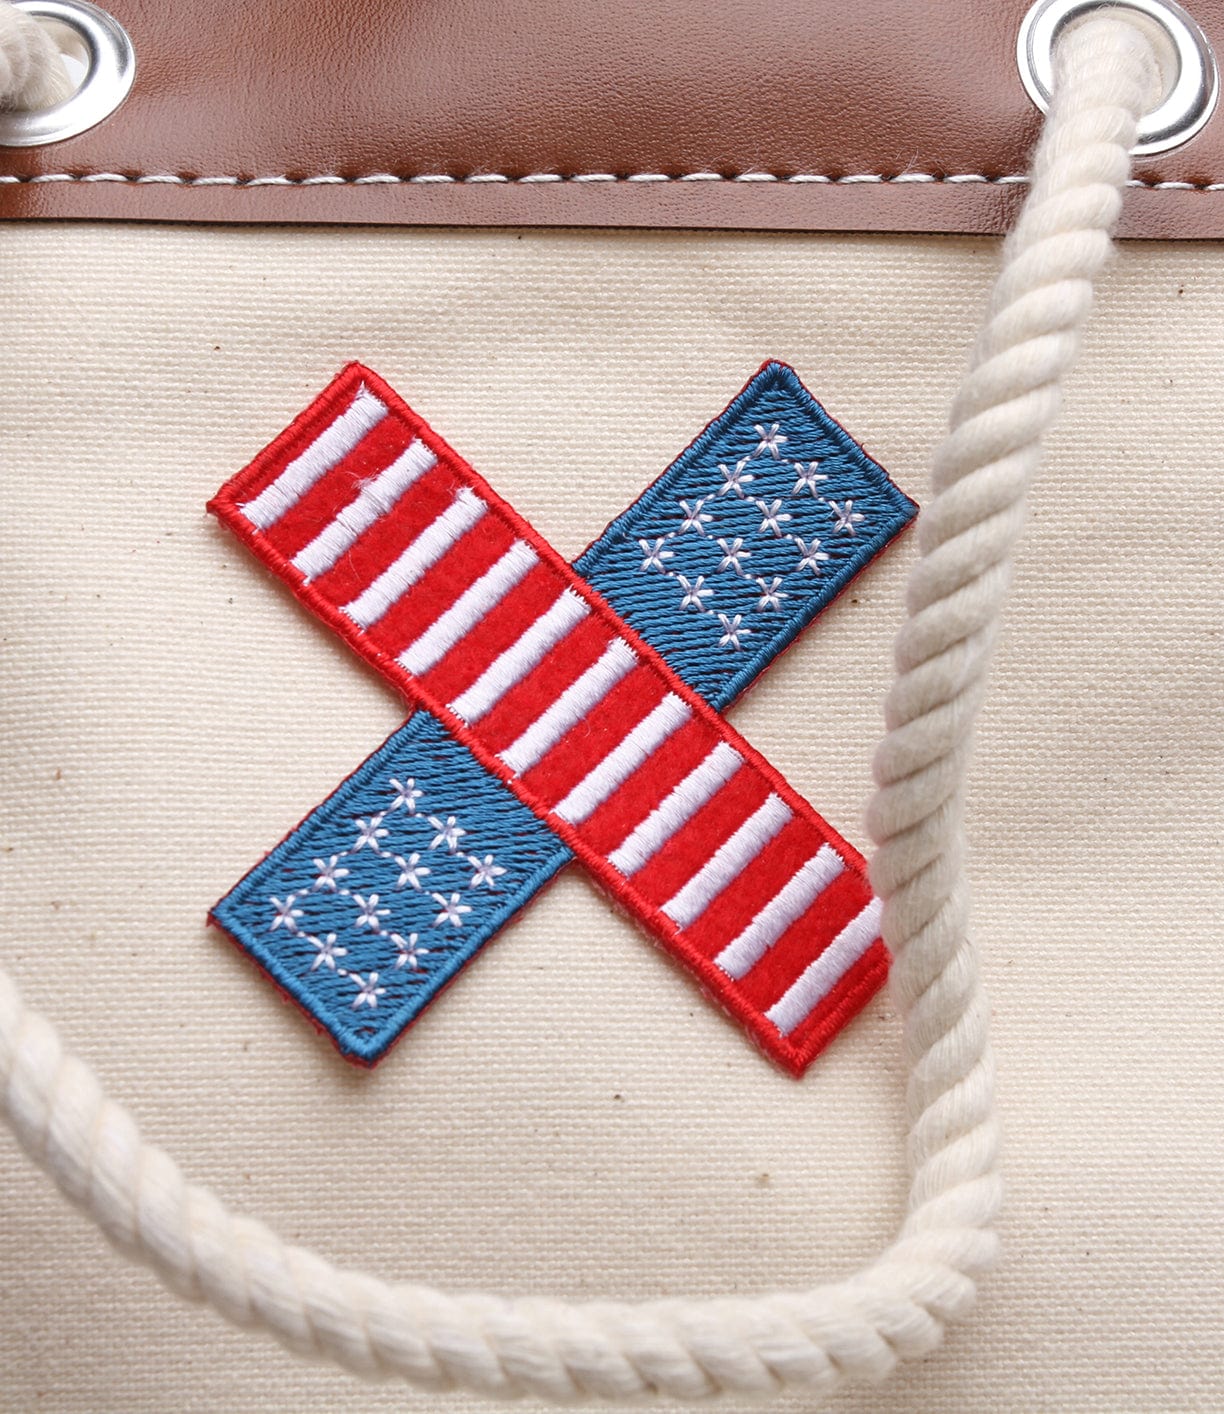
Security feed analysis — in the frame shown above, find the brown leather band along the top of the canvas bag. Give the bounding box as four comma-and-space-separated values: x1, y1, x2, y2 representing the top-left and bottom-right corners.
0, 0, 1224, 238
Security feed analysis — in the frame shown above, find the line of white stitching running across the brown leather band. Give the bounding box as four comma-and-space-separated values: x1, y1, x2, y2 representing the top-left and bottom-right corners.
0, 173, 1224, 191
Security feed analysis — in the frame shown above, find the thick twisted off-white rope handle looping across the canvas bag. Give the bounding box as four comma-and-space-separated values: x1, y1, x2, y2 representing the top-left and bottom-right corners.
0, 3, 1155, 1400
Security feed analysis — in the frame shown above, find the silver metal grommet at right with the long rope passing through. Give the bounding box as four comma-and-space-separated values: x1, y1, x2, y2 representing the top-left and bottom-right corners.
1016, 0, 1220, 154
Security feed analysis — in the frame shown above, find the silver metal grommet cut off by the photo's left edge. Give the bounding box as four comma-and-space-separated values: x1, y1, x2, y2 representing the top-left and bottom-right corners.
0, 0, 136, 147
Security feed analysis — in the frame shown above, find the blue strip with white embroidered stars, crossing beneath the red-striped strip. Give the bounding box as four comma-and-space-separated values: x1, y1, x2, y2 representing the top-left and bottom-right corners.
212, 363, 917, 1065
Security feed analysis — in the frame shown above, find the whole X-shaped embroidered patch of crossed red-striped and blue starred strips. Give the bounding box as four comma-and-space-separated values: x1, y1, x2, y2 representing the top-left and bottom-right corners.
211, 363, 916, 1075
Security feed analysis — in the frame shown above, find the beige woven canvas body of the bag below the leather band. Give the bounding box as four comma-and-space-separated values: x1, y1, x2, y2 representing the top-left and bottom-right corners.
0, 226, 1224, 1414
